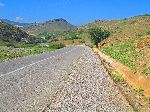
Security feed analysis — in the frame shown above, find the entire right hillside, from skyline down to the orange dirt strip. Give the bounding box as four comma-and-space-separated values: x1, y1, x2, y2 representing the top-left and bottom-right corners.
81, 16, 150, 77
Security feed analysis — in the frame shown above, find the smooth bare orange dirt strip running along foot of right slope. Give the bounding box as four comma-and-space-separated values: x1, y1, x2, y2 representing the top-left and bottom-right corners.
94, 49, 150, 97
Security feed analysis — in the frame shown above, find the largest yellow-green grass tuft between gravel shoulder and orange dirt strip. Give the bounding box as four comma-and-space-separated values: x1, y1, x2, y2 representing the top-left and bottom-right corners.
111, 71, 124, 83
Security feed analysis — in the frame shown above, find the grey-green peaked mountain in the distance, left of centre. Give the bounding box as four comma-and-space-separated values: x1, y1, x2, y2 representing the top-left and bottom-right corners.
23, 18, 76, 34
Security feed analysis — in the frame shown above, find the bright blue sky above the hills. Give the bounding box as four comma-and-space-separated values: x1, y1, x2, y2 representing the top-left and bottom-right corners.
0, 0, 150, 25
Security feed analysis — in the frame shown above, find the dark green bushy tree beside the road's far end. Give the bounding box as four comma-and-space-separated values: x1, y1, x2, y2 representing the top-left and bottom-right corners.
89, 27, 110, 48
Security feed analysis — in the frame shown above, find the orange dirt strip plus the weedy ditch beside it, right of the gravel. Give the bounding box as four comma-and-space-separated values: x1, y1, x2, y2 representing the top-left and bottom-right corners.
93, 48, 150, 112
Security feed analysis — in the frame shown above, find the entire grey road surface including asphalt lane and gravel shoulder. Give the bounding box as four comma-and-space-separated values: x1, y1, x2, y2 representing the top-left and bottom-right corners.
0, 46, 133, 112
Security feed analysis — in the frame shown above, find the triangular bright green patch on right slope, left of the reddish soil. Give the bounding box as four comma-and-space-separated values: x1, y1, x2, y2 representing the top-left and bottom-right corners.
101, 39, 139, 71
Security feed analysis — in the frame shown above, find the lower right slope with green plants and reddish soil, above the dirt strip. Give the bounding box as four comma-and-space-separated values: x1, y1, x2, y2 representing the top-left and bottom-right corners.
101, 36, 150, 77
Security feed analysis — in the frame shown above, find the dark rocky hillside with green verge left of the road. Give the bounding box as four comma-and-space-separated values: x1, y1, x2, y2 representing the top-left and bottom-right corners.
0, 21, 65, 61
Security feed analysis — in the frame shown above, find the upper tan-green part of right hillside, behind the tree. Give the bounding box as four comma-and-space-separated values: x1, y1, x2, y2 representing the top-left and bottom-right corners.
84, 16, 150, 46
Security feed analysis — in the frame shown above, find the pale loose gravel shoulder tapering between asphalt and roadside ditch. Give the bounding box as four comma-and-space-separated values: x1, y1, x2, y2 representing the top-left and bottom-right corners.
44, 48, 133, 112
